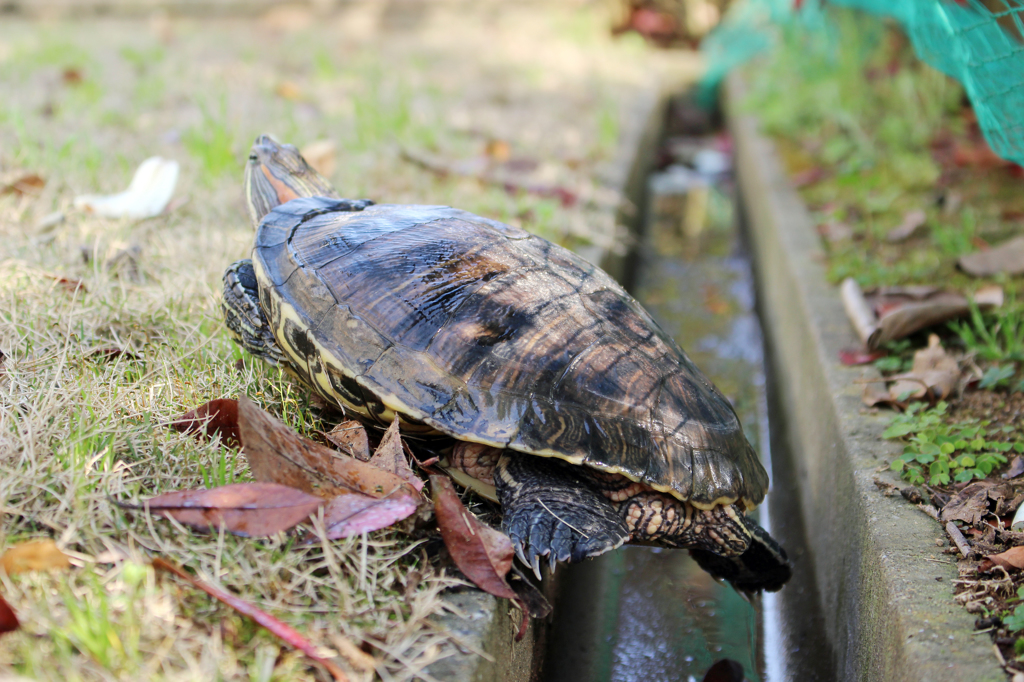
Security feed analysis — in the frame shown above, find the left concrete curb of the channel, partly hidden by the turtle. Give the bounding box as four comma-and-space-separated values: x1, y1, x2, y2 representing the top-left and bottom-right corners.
426, 74, 678, 682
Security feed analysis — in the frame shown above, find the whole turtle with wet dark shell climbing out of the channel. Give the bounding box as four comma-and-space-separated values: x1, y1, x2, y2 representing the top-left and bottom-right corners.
223, 135, 791, 593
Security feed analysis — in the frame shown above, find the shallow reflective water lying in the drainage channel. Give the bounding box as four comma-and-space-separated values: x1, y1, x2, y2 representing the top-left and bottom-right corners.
545, 114, 833, 682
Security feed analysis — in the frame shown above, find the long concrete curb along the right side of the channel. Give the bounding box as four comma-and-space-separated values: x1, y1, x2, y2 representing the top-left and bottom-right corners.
725, 75, 1006, 682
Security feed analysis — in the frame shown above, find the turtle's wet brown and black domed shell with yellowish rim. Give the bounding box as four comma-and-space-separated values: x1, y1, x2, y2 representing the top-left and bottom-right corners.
253, 193, 768, 508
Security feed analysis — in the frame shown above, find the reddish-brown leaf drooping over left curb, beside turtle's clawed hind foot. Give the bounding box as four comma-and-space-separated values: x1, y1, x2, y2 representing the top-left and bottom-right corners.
430, 475, 517, 599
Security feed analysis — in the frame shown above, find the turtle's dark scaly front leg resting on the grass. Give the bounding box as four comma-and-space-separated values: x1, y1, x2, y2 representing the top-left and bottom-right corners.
222, 258, 285, 365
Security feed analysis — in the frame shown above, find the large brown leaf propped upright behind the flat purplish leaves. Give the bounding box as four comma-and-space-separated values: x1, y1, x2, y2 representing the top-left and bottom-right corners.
239, 395, 419, 499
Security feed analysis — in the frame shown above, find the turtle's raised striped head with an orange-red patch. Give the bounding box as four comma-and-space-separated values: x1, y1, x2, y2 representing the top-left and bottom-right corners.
245, 135, 338, 228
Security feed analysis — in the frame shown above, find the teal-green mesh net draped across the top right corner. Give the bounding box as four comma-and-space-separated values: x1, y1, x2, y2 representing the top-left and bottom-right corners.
701, 0, 1024, 165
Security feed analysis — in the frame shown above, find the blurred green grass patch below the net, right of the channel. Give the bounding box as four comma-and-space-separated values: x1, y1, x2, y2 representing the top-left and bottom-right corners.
745, 8, 1024, 291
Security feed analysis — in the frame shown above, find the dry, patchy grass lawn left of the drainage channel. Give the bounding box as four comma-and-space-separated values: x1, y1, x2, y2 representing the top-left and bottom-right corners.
0, 5, 652, 680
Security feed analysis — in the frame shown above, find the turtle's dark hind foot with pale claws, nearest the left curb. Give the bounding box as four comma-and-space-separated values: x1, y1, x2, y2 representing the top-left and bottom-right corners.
494, 452, 629, 579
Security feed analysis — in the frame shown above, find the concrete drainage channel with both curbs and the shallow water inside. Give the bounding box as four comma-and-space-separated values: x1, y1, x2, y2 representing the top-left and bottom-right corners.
429, 74, 1005, 682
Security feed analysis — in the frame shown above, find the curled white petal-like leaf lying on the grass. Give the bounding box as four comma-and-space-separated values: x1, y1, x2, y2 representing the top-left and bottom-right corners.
75, 157, 178, 219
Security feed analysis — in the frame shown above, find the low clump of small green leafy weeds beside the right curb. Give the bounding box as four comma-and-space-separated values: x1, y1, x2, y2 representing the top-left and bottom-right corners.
882, 402, 1024, 485
